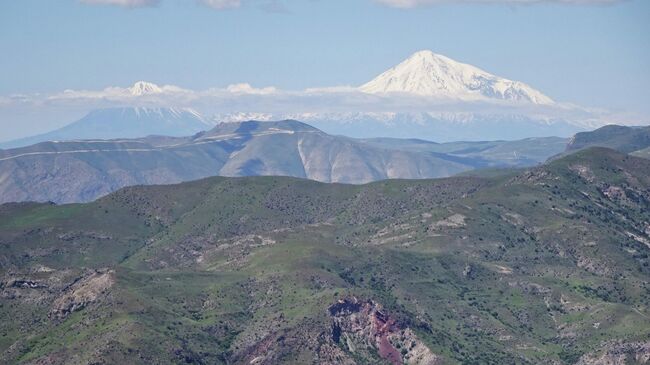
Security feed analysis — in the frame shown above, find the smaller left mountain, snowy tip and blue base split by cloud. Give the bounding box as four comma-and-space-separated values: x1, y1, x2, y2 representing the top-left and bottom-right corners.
0, 106, 213, 148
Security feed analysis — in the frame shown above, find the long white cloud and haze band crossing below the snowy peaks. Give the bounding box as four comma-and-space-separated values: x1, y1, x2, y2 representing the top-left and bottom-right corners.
0, 82, 647, 133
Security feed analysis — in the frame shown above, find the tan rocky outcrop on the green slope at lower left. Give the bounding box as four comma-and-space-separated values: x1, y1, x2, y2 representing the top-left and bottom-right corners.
50, 270, 115, 319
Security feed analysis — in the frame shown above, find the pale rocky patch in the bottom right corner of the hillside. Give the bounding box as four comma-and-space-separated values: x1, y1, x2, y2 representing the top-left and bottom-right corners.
576, 341, 650, 365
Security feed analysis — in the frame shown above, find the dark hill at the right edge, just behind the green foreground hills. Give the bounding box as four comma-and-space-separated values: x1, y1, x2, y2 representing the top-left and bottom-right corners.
566, 125, 650, 153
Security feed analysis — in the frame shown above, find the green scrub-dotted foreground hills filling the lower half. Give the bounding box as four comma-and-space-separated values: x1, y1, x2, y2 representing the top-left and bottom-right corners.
0, 146, 650, 365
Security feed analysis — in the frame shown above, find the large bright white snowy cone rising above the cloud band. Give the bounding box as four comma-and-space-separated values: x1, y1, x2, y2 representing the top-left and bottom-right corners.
359, 51, 553, 104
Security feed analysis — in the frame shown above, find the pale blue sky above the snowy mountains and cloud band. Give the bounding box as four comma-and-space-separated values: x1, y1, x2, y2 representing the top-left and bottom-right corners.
0, 0, 650, 139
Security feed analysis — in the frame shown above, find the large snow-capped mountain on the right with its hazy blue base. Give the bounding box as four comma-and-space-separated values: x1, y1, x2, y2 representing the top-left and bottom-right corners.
214, 51, 588, 142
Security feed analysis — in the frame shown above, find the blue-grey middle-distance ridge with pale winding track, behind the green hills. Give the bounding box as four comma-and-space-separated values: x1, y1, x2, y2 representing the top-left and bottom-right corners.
0, 121, 565, 203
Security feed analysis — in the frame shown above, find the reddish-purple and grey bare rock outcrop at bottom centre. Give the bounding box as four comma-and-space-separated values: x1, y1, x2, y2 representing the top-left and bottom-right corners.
329, 297, 441, 365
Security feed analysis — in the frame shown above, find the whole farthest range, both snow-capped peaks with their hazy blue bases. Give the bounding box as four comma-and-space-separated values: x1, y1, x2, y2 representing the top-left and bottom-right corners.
0, 51, 604, 148
